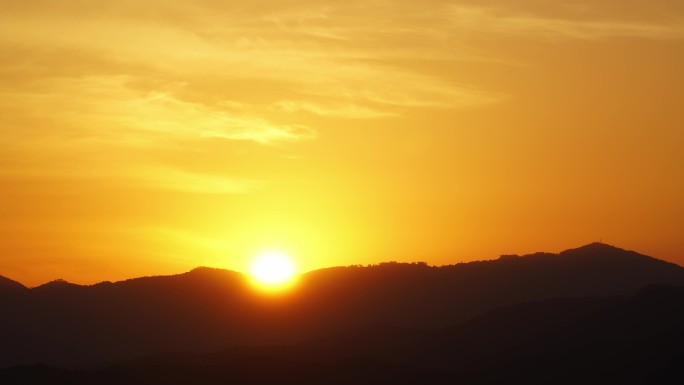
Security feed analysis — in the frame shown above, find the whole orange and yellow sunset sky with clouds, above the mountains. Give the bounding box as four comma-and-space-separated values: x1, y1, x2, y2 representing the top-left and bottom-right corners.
0, 0, 684, 285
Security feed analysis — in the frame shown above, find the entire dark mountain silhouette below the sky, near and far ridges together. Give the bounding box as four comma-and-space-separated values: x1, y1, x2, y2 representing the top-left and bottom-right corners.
0, 243, 684, 384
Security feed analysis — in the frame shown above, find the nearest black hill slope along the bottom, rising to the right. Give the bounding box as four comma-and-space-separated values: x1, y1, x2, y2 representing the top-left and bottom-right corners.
0, 286, 684, 385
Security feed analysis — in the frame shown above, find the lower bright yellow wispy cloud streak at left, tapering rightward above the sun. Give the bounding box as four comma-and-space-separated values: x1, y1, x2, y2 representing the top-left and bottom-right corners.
0, 76, 315, 145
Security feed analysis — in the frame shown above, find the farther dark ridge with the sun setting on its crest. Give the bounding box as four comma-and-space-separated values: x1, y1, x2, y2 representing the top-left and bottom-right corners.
0, 244, 684, 367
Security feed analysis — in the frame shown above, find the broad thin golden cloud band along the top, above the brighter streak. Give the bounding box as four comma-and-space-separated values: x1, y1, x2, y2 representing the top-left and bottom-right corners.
0, 1, 499, 121
